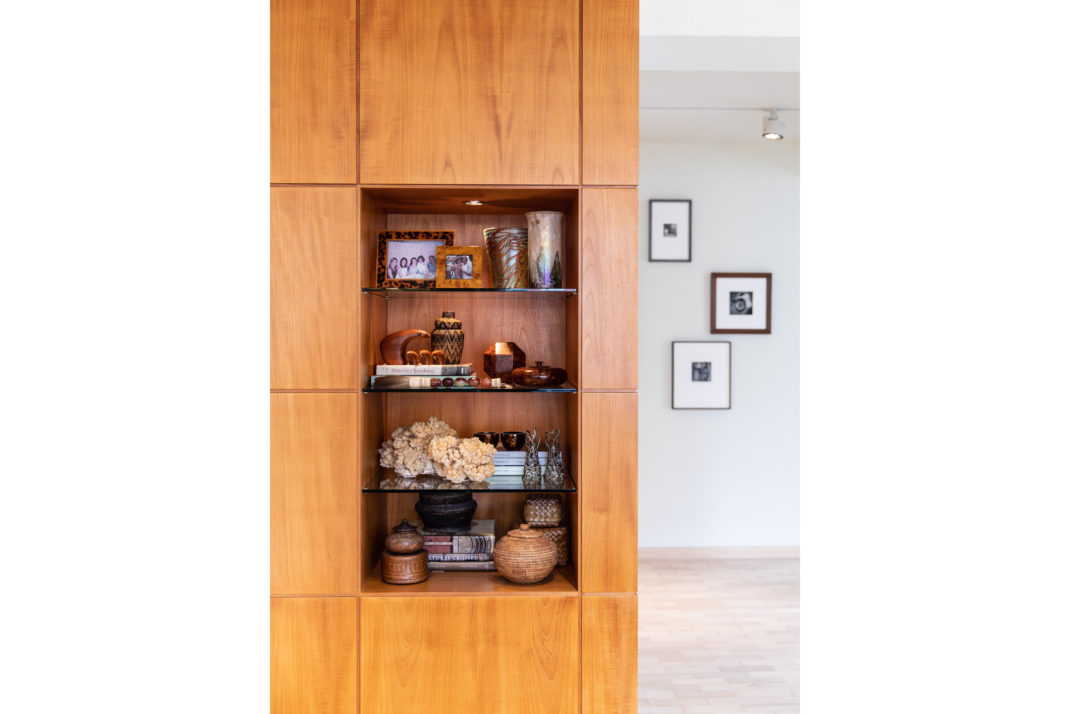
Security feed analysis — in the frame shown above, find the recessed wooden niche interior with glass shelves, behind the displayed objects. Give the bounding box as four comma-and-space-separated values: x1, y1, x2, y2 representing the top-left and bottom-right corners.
358, 186, 582, 595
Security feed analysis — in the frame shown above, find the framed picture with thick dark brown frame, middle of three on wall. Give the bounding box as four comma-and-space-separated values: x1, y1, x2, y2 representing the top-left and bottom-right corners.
709, 273, 773, 335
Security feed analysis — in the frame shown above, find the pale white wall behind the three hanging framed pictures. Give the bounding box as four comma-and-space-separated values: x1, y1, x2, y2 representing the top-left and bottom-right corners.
639, 136, 799, 547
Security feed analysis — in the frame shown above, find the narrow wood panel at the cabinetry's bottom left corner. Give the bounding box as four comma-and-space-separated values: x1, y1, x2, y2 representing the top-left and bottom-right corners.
271, 597, 358, 714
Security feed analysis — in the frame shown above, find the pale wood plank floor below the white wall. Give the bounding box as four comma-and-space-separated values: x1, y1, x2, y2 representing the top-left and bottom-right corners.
639, 549, 799, 714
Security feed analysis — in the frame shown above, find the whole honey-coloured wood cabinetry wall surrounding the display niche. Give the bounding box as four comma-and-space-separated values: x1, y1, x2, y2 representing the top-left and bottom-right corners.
271, 0, 639, 714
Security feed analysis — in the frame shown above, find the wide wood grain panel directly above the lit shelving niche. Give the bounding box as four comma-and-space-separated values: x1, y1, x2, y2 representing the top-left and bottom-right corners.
360, 0, 580, 184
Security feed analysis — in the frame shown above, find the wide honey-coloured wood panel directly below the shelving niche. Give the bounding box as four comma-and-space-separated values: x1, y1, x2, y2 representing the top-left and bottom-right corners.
361, 596, 580, 714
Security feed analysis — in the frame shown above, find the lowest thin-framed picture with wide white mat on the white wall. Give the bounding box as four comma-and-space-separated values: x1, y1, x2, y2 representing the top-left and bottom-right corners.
672, 341, 732, 409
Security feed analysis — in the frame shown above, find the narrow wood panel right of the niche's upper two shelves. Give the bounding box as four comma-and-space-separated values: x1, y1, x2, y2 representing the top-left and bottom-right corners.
580, 188, 639, 390
